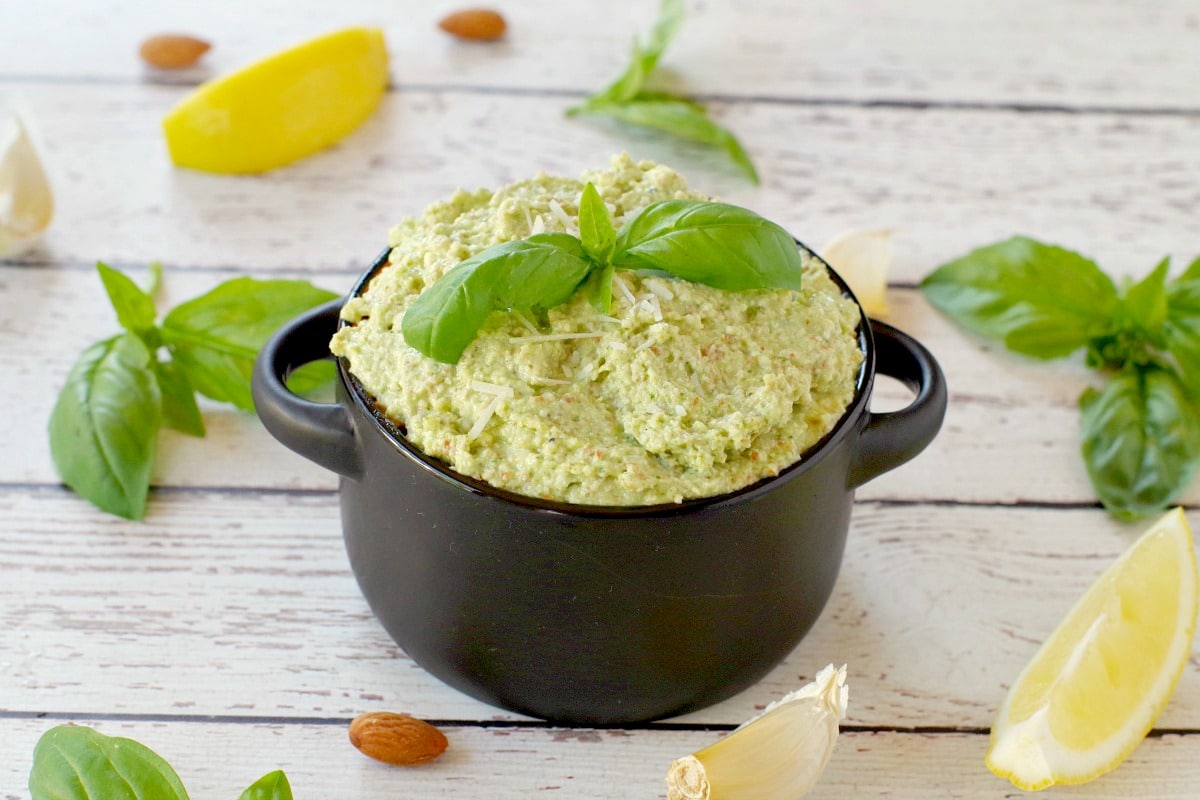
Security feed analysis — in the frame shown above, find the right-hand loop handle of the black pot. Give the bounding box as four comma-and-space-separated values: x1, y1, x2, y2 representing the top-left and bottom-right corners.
850, 319, 947, 488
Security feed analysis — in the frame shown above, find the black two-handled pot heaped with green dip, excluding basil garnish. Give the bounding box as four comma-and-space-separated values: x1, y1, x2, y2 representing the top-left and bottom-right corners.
254, 157, 946, 724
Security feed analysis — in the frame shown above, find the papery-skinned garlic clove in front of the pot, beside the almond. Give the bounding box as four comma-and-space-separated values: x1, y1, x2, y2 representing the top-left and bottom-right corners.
666, 664, 850, 800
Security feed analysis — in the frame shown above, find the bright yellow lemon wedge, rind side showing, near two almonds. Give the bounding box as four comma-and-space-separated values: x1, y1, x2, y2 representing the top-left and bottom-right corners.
162, 28, 388, 173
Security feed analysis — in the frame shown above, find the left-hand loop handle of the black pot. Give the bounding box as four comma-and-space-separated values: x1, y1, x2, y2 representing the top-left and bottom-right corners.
251, 300, 362, 477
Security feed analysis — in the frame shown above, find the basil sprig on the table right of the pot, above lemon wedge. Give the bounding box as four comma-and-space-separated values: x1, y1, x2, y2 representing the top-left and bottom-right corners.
920, 236, 1200, 519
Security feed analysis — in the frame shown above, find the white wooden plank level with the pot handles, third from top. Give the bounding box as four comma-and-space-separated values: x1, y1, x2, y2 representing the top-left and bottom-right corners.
7, 266, 1200, 505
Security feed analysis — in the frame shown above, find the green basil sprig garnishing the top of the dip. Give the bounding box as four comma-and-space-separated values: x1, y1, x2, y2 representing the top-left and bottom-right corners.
401, 184, 804, 363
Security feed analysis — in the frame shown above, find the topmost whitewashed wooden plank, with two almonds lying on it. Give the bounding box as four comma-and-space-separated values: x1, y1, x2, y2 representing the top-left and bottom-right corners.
0, 0, 1200, 110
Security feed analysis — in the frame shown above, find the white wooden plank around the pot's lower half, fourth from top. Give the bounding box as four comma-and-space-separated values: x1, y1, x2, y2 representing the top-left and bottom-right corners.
0, 489, 1200, 729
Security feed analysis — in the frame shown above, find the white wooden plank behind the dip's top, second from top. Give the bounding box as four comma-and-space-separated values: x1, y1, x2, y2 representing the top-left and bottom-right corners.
0, 82, 1200, 284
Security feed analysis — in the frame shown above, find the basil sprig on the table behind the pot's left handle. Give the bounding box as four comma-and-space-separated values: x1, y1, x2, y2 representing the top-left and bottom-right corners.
49, 263, 337, 519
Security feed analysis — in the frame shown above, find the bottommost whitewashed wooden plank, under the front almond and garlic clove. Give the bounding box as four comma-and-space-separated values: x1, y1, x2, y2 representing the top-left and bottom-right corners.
0, 716, 1200, 800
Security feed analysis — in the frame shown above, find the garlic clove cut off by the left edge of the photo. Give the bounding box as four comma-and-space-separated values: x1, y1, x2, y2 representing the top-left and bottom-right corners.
0, 95, 54, 258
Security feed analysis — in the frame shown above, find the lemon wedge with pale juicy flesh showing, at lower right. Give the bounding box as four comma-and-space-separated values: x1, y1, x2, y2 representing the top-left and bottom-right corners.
985, 509, 1198, 792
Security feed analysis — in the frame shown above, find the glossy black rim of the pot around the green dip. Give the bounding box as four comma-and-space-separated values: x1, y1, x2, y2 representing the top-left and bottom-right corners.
337, 240, 875, 519
